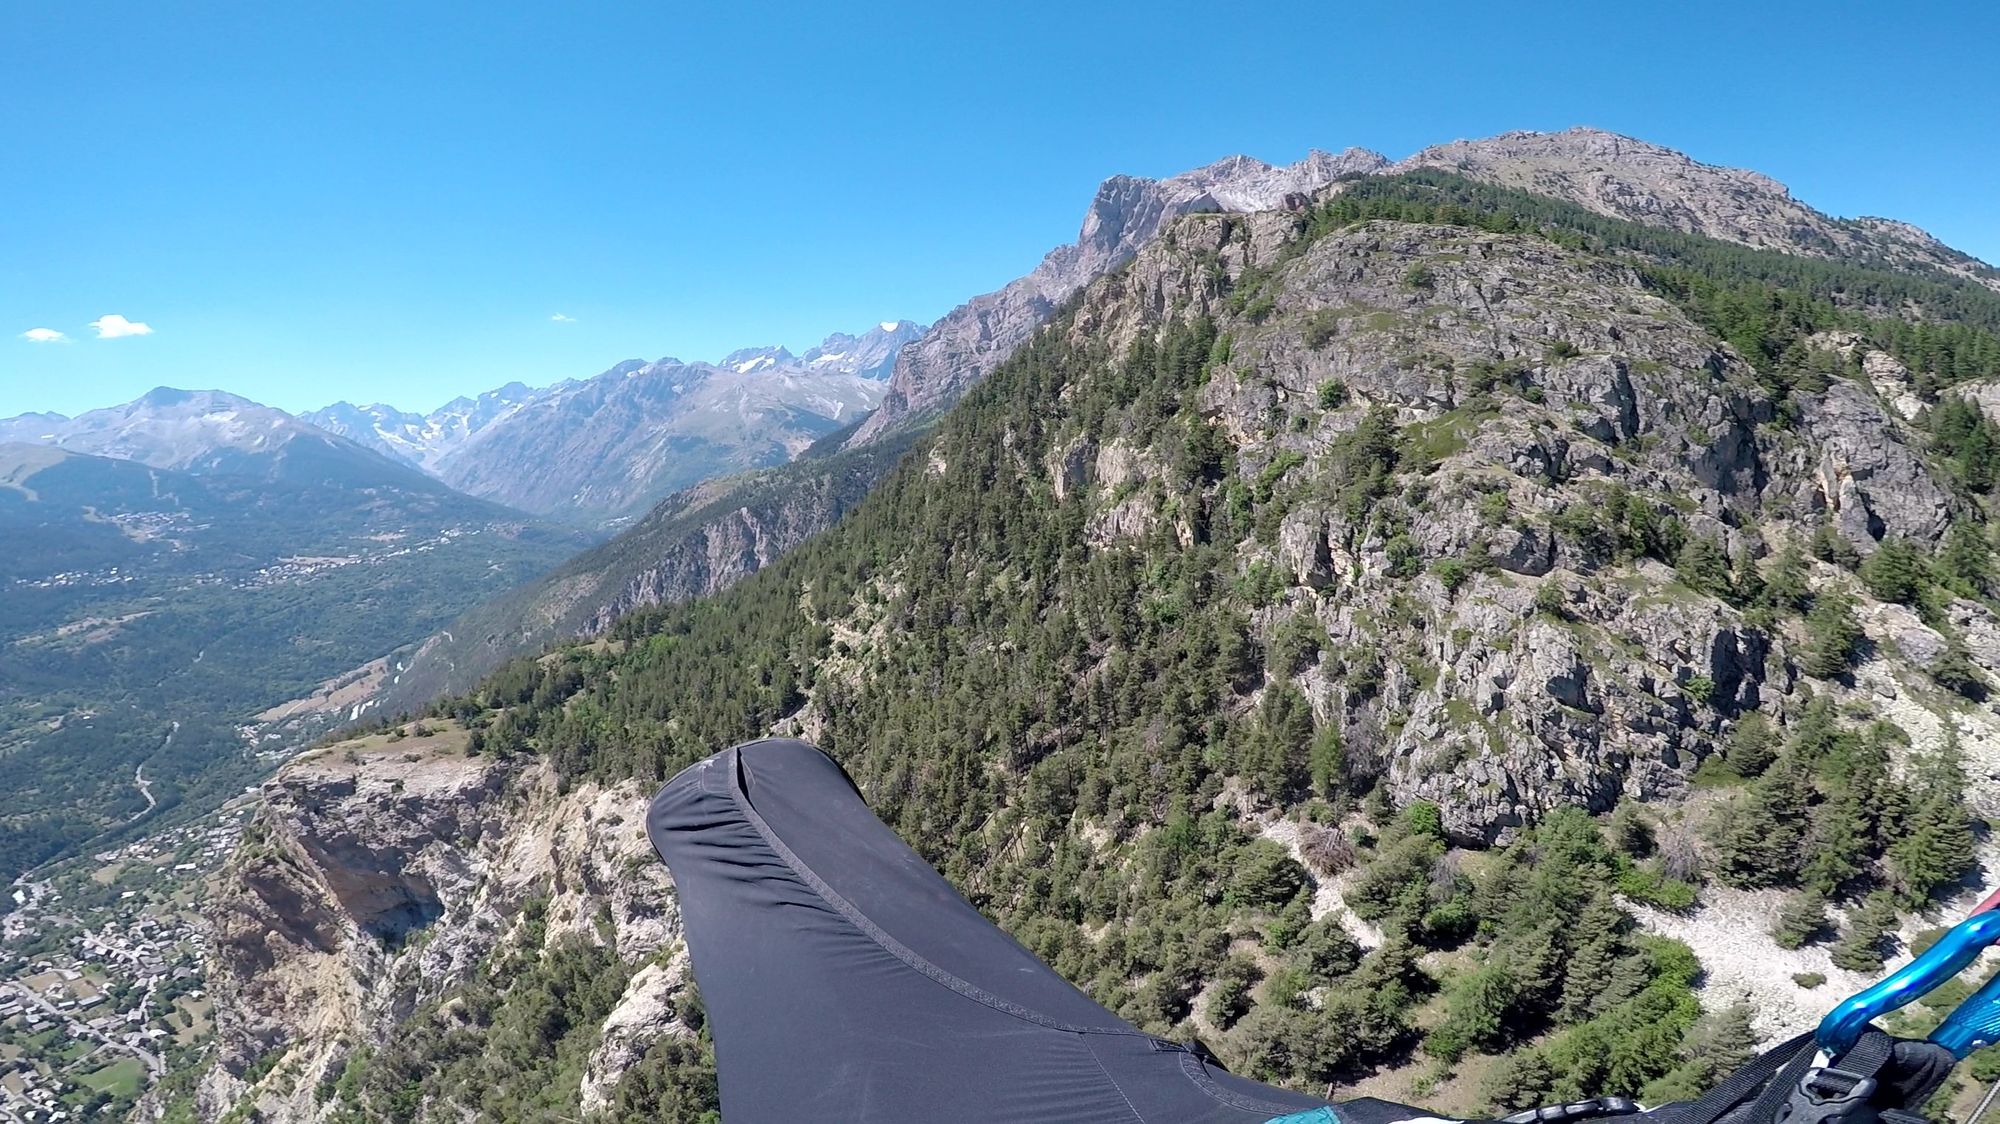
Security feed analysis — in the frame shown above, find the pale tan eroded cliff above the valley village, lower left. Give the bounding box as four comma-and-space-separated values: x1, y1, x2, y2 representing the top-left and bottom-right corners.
202, 728, 692, 1120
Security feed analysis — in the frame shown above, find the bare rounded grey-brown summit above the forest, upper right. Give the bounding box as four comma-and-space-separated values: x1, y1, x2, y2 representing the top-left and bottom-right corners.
1386, 128, 2000, 288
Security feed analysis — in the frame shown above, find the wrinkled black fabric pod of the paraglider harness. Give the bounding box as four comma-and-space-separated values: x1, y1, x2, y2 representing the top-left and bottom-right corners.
646, 738, 1352, 1124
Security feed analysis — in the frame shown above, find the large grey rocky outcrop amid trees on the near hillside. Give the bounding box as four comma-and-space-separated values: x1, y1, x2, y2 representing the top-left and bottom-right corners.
1016, 214, 1952, 842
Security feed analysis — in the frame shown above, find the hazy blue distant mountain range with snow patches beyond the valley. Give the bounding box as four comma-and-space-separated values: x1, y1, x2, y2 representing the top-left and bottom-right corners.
0, 320, 924, 524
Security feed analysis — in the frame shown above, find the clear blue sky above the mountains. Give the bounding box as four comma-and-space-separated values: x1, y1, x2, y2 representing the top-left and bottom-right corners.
0, 0, 2000, 416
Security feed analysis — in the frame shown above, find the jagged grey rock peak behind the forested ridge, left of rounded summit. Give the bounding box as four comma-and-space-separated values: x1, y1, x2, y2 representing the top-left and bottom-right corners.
848, 148, 1388, 446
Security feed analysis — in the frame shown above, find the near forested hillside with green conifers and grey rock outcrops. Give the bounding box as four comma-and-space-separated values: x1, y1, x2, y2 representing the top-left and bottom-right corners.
230, 172, 2000, 1120
